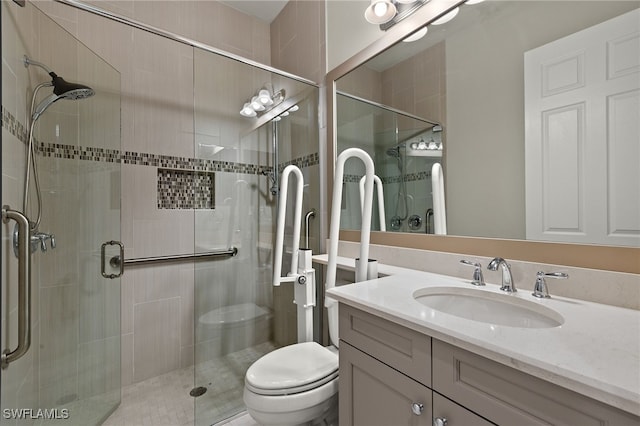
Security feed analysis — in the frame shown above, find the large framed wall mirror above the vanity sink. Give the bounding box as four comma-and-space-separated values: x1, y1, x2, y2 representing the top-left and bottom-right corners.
334, 1, 640, 247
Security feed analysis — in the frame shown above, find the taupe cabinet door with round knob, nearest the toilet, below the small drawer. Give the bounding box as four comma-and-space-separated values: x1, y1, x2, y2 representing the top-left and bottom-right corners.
339, 341, 432, 426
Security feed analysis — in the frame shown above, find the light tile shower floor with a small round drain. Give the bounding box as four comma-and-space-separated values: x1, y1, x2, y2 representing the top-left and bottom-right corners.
103, 343, 274, 426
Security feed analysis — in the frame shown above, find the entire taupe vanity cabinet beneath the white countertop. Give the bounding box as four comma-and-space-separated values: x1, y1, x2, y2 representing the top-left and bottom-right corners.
339, 304, 640, 426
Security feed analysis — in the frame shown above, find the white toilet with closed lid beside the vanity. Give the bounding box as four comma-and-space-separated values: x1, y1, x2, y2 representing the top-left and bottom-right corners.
243, 304, 338, 426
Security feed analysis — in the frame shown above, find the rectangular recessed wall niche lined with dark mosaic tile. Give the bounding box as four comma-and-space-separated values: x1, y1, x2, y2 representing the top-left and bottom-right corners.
158, 168, 215, 209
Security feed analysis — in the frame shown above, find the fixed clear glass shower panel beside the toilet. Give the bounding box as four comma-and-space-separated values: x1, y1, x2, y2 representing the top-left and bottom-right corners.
194, 49, 319, 425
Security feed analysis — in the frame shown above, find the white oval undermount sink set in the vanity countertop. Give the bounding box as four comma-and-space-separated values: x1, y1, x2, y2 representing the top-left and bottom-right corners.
413, 287, 564, 328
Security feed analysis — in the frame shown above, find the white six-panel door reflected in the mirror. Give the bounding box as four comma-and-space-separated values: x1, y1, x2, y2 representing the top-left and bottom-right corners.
524, 9, 640, 247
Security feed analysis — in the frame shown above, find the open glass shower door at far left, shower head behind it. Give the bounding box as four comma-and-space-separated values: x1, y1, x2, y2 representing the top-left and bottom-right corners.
0, 2, 120, 425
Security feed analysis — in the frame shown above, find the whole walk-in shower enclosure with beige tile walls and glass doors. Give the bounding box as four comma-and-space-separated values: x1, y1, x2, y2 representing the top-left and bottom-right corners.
0, 2, 320, 425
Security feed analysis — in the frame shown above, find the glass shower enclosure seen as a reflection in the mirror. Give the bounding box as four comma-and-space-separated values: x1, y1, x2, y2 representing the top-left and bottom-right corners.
336, 92, 444, 233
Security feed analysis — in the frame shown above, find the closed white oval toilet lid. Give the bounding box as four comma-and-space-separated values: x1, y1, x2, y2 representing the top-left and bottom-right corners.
245, 342, 338, 395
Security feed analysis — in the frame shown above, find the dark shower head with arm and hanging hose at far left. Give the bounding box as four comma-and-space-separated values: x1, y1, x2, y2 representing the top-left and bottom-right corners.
22, 55, 95, 231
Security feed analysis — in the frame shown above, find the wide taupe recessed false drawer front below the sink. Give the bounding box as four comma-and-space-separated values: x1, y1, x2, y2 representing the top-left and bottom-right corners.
430, 339, 640, 426
